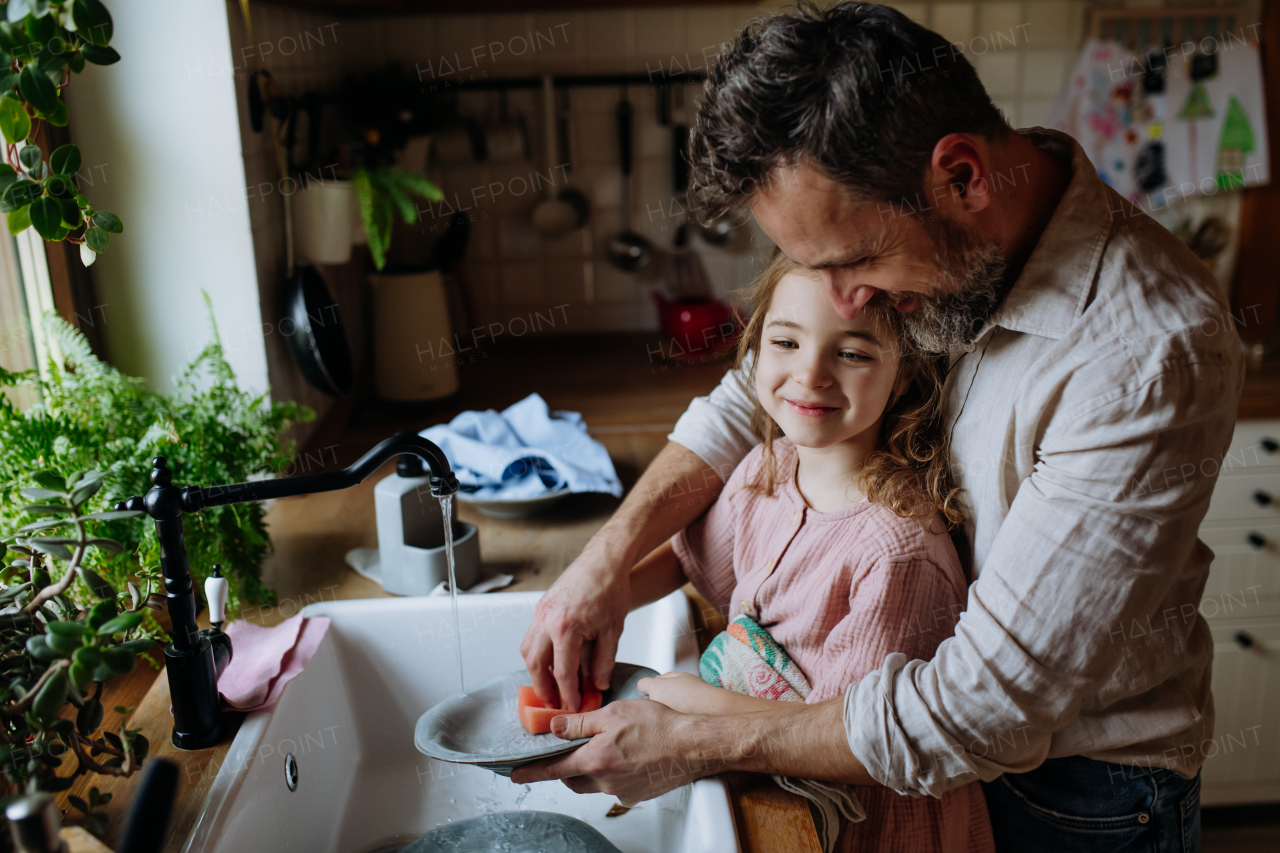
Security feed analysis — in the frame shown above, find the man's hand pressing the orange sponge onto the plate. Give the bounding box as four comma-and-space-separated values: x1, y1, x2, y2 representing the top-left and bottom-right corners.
520, 547, 631, 711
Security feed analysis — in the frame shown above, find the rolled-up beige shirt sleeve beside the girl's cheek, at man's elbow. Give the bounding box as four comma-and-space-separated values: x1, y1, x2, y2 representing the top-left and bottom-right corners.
667, 360, 759, 482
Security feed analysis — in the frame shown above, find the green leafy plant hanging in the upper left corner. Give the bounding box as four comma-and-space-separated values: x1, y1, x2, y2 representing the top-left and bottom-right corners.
0, 0, 124, 266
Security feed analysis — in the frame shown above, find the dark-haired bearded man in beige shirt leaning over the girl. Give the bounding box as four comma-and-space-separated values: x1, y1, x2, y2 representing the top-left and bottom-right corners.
512, 3, 1243, 850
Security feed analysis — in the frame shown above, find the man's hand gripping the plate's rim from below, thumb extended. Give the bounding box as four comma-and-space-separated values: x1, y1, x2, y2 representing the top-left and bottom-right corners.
511, 699, 726, 806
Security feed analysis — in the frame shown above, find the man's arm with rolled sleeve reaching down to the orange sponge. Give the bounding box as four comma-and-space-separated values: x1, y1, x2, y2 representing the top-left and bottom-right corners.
520, 361, 755, 708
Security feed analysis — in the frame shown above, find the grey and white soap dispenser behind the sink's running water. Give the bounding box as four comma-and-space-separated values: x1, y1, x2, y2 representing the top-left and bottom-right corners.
374, 455, 480, 596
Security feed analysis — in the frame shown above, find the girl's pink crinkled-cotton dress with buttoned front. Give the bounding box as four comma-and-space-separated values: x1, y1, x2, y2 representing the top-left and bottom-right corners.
672, 439, 995, 853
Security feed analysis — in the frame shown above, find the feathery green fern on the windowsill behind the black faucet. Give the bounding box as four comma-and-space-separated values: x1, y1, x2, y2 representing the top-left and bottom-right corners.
0, 303, 315, 613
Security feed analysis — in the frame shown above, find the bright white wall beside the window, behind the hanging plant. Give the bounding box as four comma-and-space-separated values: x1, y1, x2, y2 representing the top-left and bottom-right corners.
65, 0, 268, 389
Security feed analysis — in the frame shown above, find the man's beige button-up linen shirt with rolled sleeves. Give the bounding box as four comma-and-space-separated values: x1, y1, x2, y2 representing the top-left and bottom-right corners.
671, 128, 1244, 795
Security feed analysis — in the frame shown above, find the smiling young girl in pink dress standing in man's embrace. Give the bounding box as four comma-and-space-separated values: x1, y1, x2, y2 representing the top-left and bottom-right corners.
631, 254, 995, 853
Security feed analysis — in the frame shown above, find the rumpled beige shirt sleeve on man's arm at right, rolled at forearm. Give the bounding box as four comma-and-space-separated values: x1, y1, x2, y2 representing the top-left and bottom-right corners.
845, 348, 1239, 797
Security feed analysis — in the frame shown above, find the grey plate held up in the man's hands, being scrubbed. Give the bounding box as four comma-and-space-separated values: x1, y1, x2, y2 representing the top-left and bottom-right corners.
413, 663, 658, 776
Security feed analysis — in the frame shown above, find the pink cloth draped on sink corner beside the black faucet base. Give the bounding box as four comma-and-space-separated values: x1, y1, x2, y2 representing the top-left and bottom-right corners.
218, 613, 329, 711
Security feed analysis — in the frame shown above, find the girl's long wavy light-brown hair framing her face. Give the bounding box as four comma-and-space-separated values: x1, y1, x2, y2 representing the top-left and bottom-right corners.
736, 245, 965, 530
